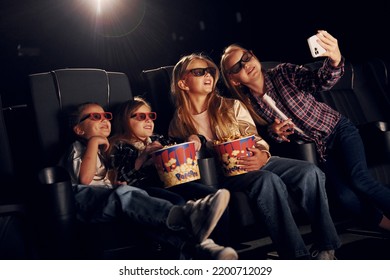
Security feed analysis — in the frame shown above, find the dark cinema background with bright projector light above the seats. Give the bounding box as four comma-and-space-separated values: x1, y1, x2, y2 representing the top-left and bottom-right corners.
0, 0, 390, 106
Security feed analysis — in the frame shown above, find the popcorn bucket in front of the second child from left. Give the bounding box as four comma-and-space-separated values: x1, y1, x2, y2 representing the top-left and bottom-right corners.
152, 142, 200, 188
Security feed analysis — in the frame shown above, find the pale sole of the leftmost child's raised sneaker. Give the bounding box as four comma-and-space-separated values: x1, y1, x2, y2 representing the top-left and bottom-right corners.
195, 189, 230, 243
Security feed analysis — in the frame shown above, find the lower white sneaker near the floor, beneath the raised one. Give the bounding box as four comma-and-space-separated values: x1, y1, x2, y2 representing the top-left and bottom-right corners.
196, 239, 238, 260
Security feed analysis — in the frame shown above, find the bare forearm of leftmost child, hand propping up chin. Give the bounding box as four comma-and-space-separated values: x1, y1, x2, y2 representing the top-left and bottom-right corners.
79, 136, 109, 185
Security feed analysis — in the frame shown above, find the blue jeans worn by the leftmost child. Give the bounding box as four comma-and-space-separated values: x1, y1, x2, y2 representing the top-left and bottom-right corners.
75, 185, 189, 250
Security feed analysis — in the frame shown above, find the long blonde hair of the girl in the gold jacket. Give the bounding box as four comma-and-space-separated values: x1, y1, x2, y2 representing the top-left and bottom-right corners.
169, 54, 238, 139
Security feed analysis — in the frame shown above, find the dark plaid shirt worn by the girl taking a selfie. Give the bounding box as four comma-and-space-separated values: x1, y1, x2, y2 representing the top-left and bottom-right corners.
250, 58, 344, 161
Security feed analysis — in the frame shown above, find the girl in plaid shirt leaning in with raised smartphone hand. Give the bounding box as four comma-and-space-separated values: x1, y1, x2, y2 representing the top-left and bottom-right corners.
220, 30, 390, 234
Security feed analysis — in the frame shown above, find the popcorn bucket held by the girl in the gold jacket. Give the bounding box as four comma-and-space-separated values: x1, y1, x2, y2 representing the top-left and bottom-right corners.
214, 135, 255, 176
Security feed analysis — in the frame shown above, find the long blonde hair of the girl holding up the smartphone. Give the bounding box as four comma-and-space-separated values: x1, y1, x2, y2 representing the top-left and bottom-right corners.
220, 44, 267, 125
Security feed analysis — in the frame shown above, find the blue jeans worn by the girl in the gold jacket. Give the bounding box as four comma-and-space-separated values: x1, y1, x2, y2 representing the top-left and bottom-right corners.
225, 157, 341, 259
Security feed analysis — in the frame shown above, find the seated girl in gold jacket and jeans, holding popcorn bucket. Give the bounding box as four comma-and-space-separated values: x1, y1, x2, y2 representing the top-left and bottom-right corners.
169, 54, 341, 260
